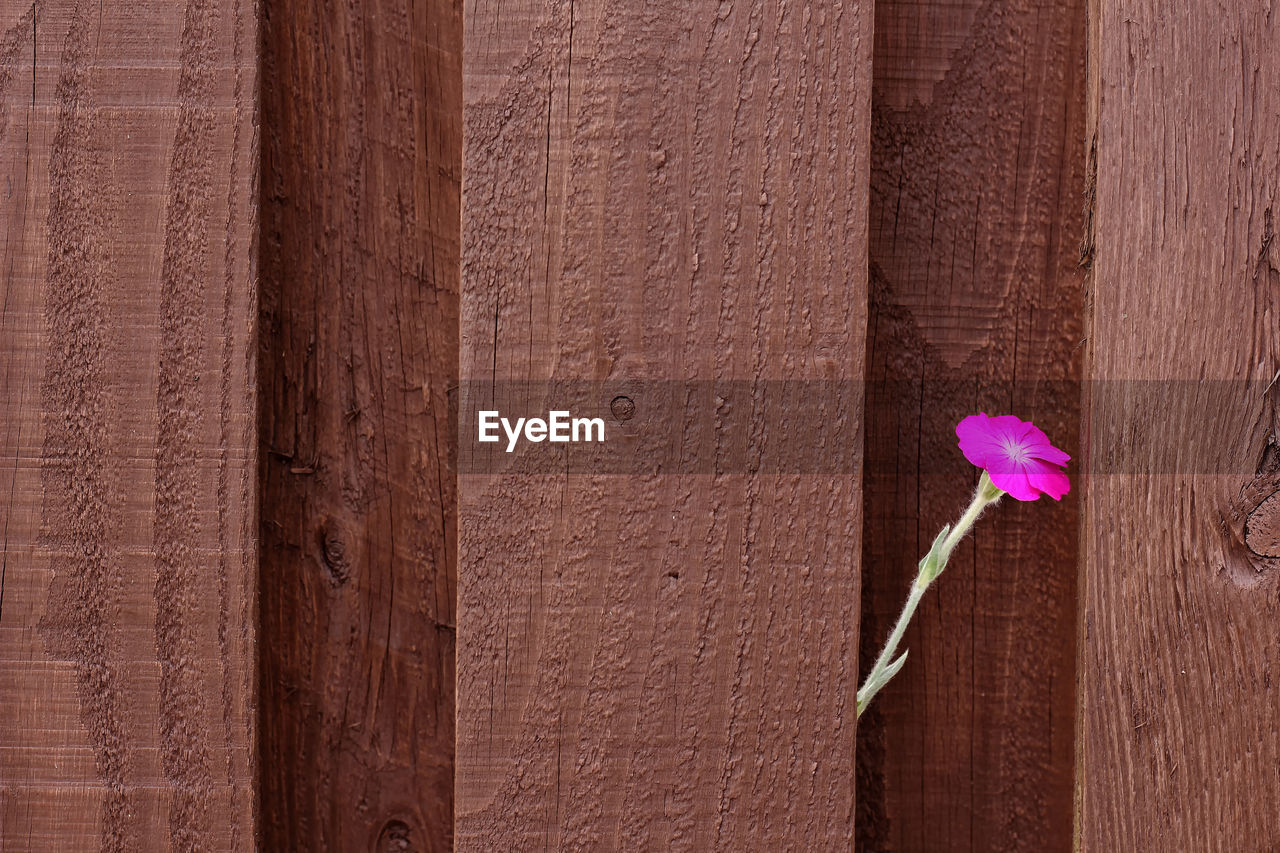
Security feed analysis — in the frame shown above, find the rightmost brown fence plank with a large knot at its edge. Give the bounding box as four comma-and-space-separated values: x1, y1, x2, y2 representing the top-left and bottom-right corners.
1078, 0, 1280, 852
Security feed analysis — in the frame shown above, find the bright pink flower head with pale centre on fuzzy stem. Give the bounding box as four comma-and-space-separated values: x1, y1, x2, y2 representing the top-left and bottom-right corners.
956, 412, 1071, 501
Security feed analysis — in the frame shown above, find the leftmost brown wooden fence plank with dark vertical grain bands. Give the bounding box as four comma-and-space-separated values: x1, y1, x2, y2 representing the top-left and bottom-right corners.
0, 0, 257, 852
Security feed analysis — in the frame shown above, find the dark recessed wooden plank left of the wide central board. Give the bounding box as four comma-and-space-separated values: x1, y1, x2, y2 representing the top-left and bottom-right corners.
260, 0, 462, 852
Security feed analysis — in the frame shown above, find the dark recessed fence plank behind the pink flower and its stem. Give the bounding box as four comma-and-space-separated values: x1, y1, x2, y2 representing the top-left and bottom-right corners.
858, 0, 1085, 852
